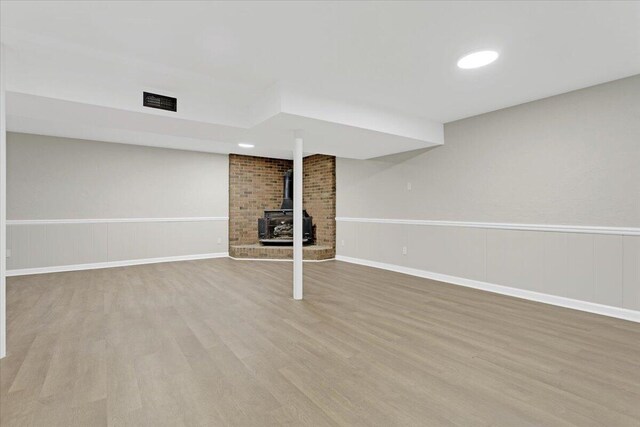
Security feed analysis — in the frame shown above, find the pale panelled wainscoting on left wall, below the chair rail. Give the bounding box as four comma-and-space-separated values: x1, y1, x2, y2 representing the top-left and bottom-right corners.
7, 218, 228, 270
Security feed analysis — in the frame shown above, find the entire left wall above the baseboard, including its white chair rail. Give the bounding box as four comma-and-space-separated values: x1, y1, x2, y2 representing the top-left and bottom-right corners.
7, 133, 228, 274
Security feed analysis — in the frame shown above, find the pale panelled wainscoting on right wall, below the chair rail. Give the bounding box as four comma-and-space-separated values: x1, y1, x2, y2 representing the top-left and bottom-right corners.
337, 218, 640, 318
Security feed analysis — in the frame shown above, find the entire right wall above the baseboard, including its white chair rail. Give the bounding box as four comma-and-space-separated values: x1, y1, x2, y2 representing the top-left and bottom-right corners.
336, 76, 640, 320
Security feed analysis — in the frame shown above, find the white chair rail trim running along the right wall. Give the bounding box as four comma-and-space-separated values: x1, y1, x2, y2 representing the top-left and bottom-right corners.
336, 217, 640, 236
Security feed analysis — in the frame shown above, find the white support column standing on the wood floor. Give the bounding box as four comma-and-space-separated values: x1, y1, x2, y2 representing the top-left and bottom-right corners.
293, 133, 303, 300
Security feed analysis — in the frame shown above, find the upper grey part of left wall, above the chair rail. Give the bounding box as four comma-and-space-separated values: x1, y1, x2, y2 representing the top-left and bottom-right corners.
7, 133, 229, 220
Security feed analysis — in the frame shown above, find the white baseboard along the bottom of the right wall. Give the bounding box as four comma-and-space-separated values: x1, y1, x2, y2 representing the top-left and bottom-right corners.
336, 255, 640, 323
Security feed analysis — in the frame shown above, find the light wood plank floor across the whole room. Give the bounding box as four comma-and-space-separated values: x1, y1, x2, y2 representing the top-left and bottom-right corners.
0, 259, 640, 427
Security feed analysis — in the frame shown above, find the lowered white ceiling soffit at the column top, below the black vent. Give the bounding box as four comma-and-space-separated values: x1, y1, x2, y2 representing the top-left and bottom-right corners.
7, 91, 443, 159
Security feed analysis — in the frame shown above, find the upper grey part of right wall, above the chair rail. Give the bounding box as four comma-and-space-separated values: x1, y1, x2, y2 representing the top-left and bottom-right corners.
336, 76, 640, 227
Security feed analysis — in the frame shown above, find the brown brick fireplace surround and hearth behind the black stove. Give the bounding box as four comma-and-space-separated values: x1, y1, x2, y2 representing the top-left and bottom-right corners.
229, 154, 336, 260
